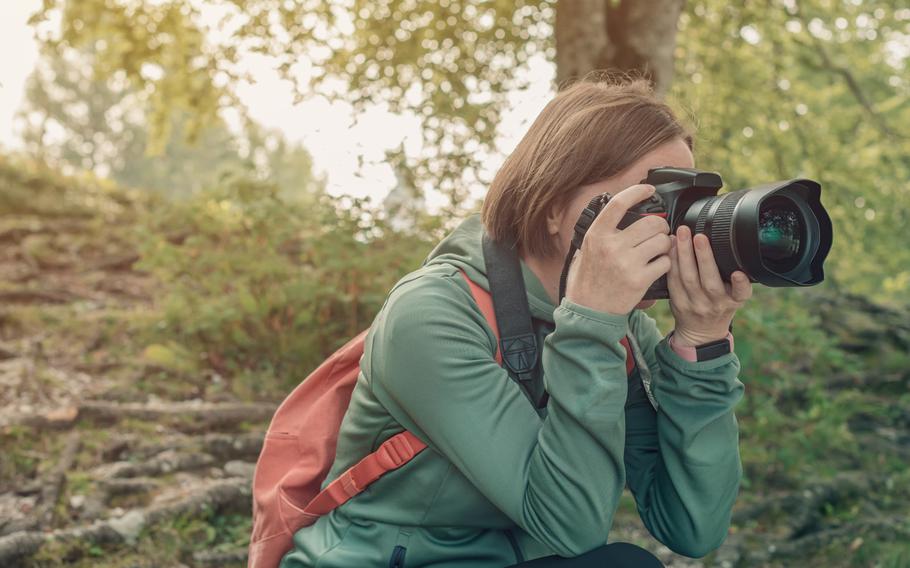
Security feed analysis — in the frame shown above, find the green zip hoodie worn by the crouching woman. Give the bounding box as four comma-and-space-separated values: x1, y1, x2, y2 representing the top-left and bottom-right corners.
281, 214, 744, 568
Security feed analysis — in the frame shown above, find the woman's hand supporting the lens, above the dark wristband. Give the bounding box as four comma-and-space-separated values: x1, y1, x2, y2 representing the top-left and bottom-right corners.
667, 225, 752, 346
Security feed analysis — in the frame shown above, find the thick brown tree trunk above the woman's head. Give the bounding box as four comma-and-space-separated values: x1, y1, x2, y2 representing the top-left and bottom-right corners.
556, 0, 685, 96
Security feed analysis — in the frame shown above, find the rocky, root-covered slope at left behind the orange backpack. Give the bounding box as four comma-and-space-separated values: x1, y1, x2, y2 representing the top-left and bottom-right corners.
0, 164, 266, 567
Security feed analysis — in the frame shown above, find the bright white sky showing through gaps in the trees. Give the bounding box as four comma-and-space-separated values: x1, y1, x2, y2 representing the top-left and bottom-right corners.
0, 0, 555, 209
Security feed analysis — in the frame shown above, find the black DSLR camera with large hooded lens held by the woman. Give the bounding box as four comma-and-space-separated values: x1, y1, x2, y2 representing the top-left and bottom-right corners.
570, 167, 833, 300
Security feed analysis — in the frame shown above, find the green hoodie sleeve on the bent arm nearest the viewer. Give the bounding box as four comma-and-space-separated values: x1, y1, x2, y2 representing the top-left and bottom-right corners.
368, 272, 628, 556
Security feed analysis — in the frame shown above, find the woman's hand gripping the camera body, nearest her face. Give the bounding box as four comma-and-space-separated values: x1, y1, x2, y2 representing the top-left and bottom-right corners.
566, 184, 671, 315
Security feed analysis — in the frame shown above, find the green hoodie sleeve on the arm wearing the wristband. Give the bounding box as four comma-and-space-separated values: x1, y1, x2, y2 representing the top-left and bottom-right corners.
626, 310, 744, 557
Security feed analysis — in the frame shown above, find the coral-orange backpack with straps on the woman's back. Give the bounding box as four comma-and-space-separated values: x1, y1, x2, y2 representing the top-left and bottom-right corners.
249, 270, 502, 568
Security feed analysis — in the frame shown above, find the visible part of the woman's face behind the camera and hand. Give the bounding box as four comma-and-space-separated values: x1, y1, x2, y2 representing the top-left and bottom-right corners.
551, 138, 695, 309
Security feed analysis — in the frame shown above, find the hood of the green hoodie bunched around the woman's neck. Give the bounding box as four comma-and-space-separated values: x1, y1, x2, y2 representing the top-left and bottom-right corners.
423, 213, 556, 322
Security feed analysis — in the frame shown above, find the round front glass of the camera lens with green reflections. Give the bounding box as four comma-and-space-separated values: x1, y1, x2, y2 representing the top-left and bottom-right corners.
758, 196, 803, 272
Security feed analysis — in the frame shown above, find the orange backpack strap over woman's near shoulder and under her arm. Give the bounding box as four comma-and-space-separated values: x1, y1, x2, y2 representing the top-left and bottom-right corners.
302, 270, 510, 520
